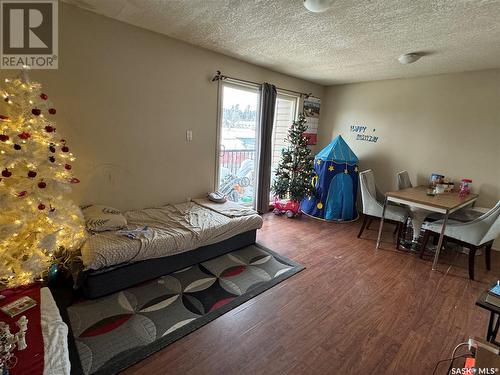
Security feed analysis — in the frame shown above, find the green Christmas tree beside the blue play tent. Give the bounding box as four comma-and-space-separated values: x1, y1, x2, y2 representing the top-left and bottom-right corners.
272, 114, 314, 202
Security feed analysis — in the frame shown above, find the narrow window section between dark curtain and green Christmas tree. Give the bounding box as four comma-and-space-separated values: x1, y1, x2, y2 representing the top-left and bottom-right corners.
270, 92, 299, 200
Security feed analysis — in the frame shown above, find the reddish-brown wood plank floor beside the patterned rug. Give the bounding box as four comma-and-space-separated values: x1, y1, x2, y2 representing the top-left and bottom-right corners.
125, 214, 500, 375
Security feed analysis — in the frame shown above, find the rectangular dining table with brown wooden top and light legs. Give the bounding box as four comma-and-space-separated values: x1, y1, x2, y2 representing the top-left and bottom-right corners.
375, 186, 478, 271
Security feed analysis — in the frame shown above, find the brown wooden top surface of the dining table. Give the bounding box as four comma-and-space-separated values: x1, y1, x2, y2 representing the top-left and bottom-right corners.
386, 186, 478, 210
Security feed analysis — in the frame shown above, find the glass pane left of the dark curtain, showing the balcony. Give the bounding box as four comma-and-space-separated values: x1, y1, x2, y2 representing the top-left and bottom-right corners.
218, 82, 260, 206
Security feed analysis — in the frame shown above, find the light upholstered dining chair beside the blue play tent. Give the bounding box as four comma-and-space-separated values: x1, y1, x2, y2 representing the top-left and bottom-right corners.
358, 169, 408, 249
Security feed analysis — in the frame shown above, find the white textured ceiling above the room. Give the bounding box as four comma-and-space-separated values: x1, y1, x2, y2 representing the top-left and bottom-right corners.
66, 0, 500, 85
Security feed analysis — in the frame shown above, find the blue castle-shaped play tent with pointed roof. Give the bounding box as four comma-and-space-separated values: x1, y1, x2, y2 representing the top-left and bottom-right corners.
300, 135, 358, 221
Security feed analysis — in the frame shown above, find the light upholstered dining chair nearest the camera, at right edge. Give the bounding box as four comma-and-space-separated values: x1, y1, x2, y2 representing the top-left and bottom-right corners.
420, 201, 500, 280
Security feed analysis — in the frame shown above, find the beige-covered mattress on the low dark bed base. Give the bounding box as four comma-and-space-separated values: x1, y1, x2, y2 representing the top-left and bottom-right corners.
82, 199, 262, 270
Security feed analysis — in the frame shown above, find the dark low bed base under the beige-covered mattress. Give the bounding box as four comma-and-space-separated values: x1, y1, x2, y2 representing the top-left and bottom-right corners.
82, 230, 257, 298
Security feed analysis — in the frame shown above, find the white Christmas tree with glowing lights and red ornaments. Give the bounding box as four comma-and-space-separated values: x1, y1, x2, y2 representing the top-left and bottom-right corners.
0, 71, 85, 287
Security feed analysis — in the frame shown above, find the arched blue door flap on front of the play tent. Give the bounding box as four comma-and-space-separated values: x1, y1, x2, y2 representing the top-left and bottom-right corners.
325, 173, 357, 220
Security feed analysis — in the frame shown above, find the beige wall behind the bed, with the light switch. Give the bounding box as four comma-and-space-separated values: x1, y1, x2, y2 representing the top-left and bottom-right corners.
0, 3, 323, 209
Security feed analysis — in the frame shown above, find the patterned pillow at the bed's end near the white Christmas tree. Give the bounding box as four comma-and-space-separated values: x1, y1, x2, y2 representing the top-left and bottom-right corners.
82, 205, 127, 232
